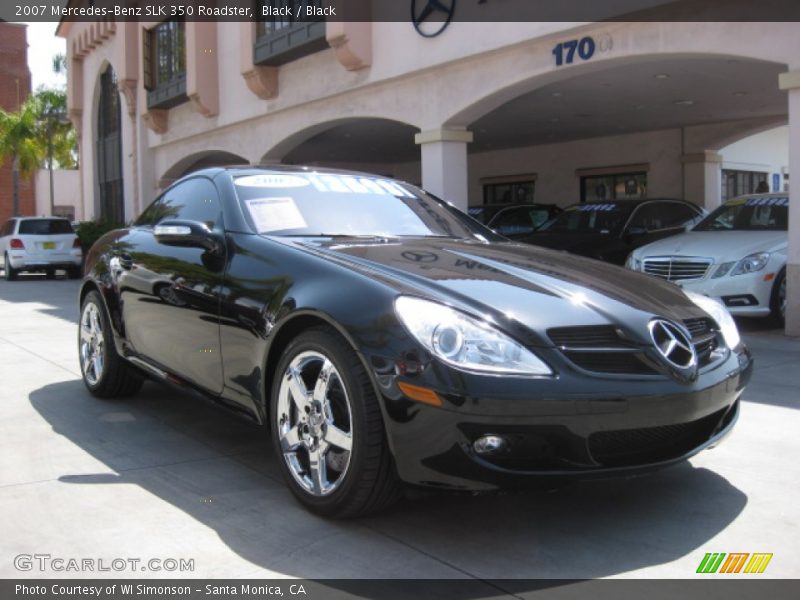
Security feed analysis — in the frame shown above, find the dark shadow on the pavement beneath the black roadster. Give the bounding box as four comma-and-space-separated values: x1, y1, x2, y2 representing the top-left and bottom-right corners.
30, 380, 747, 580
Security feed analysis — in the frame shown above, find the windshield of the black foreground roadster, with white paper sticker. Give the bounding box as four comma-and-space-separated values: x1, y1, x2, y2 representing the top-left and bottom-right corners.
234, 173, 501, 240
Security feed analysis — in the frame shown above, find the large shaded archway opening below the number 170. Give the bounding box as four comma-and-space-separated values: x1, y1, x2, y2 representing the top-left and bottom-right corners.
445, 54, 788, 208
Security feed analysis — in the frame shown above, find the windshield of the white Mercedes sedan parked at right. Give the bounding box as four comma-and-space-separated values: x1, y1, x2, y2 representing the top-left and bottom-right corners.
693, 196, 789, 231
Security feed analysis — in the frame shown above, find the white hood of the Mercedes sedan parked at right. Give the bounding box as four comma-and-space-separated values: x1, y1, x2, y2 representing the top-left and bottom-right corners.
634, 231, 789, 263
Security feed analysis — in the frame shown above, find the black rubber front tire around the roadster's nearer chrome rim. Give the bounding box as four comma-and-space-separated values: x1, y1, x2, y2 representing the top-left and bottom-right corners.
270, 327, 402, 519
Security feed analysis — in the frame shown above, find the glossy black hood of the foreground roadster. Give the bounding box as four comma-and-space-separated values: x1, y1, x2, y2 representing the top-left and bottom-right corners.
284, 238, 705, 344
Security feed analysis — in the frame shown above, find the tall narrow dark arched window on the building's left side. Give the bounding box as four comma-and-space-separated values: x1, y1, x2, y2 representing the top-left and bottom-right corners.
95, 65, 125, 223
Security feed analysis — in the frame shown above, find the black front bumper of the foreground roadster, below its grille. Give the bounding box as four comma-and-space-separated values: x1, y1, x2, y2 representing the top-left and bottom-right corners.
382, 347, 753, 491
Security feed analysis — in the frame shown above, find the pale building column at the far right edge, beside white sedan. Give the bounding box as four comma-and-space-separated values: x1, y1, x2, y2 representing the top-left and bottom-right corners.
779, 70, 800, 336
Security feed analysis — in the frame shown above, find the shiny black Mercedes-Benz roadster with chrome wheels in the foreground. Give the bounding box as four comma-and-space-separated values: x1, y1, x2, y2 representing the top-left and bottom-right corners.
78, 167, 752, 517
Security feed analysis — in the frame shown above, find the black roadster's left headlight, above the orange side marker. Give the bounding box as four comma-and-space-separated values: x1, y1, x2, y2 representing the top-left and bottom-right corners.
394, 296, 552, 375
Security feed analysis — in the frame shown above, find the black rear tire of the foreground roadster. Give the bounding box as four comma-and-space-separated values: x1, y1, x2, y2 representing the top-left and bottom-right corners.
78, 291, 144, 398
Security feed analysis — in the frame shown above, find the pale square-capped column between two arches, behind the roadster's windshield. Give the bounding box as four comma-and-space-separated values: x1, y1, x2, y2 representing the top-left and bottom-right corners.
414, 129, 472, 211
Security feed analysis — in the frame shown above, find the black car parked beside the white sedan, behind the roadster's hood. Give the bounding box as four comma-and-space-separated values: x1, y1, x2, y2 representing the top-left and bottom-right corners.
515, 198, 705, 265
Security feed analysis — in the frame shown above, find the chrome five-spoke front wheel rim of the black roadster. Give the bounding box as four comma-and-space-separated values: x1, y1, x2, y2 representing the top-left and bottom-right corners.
277, 351, 353, 496
